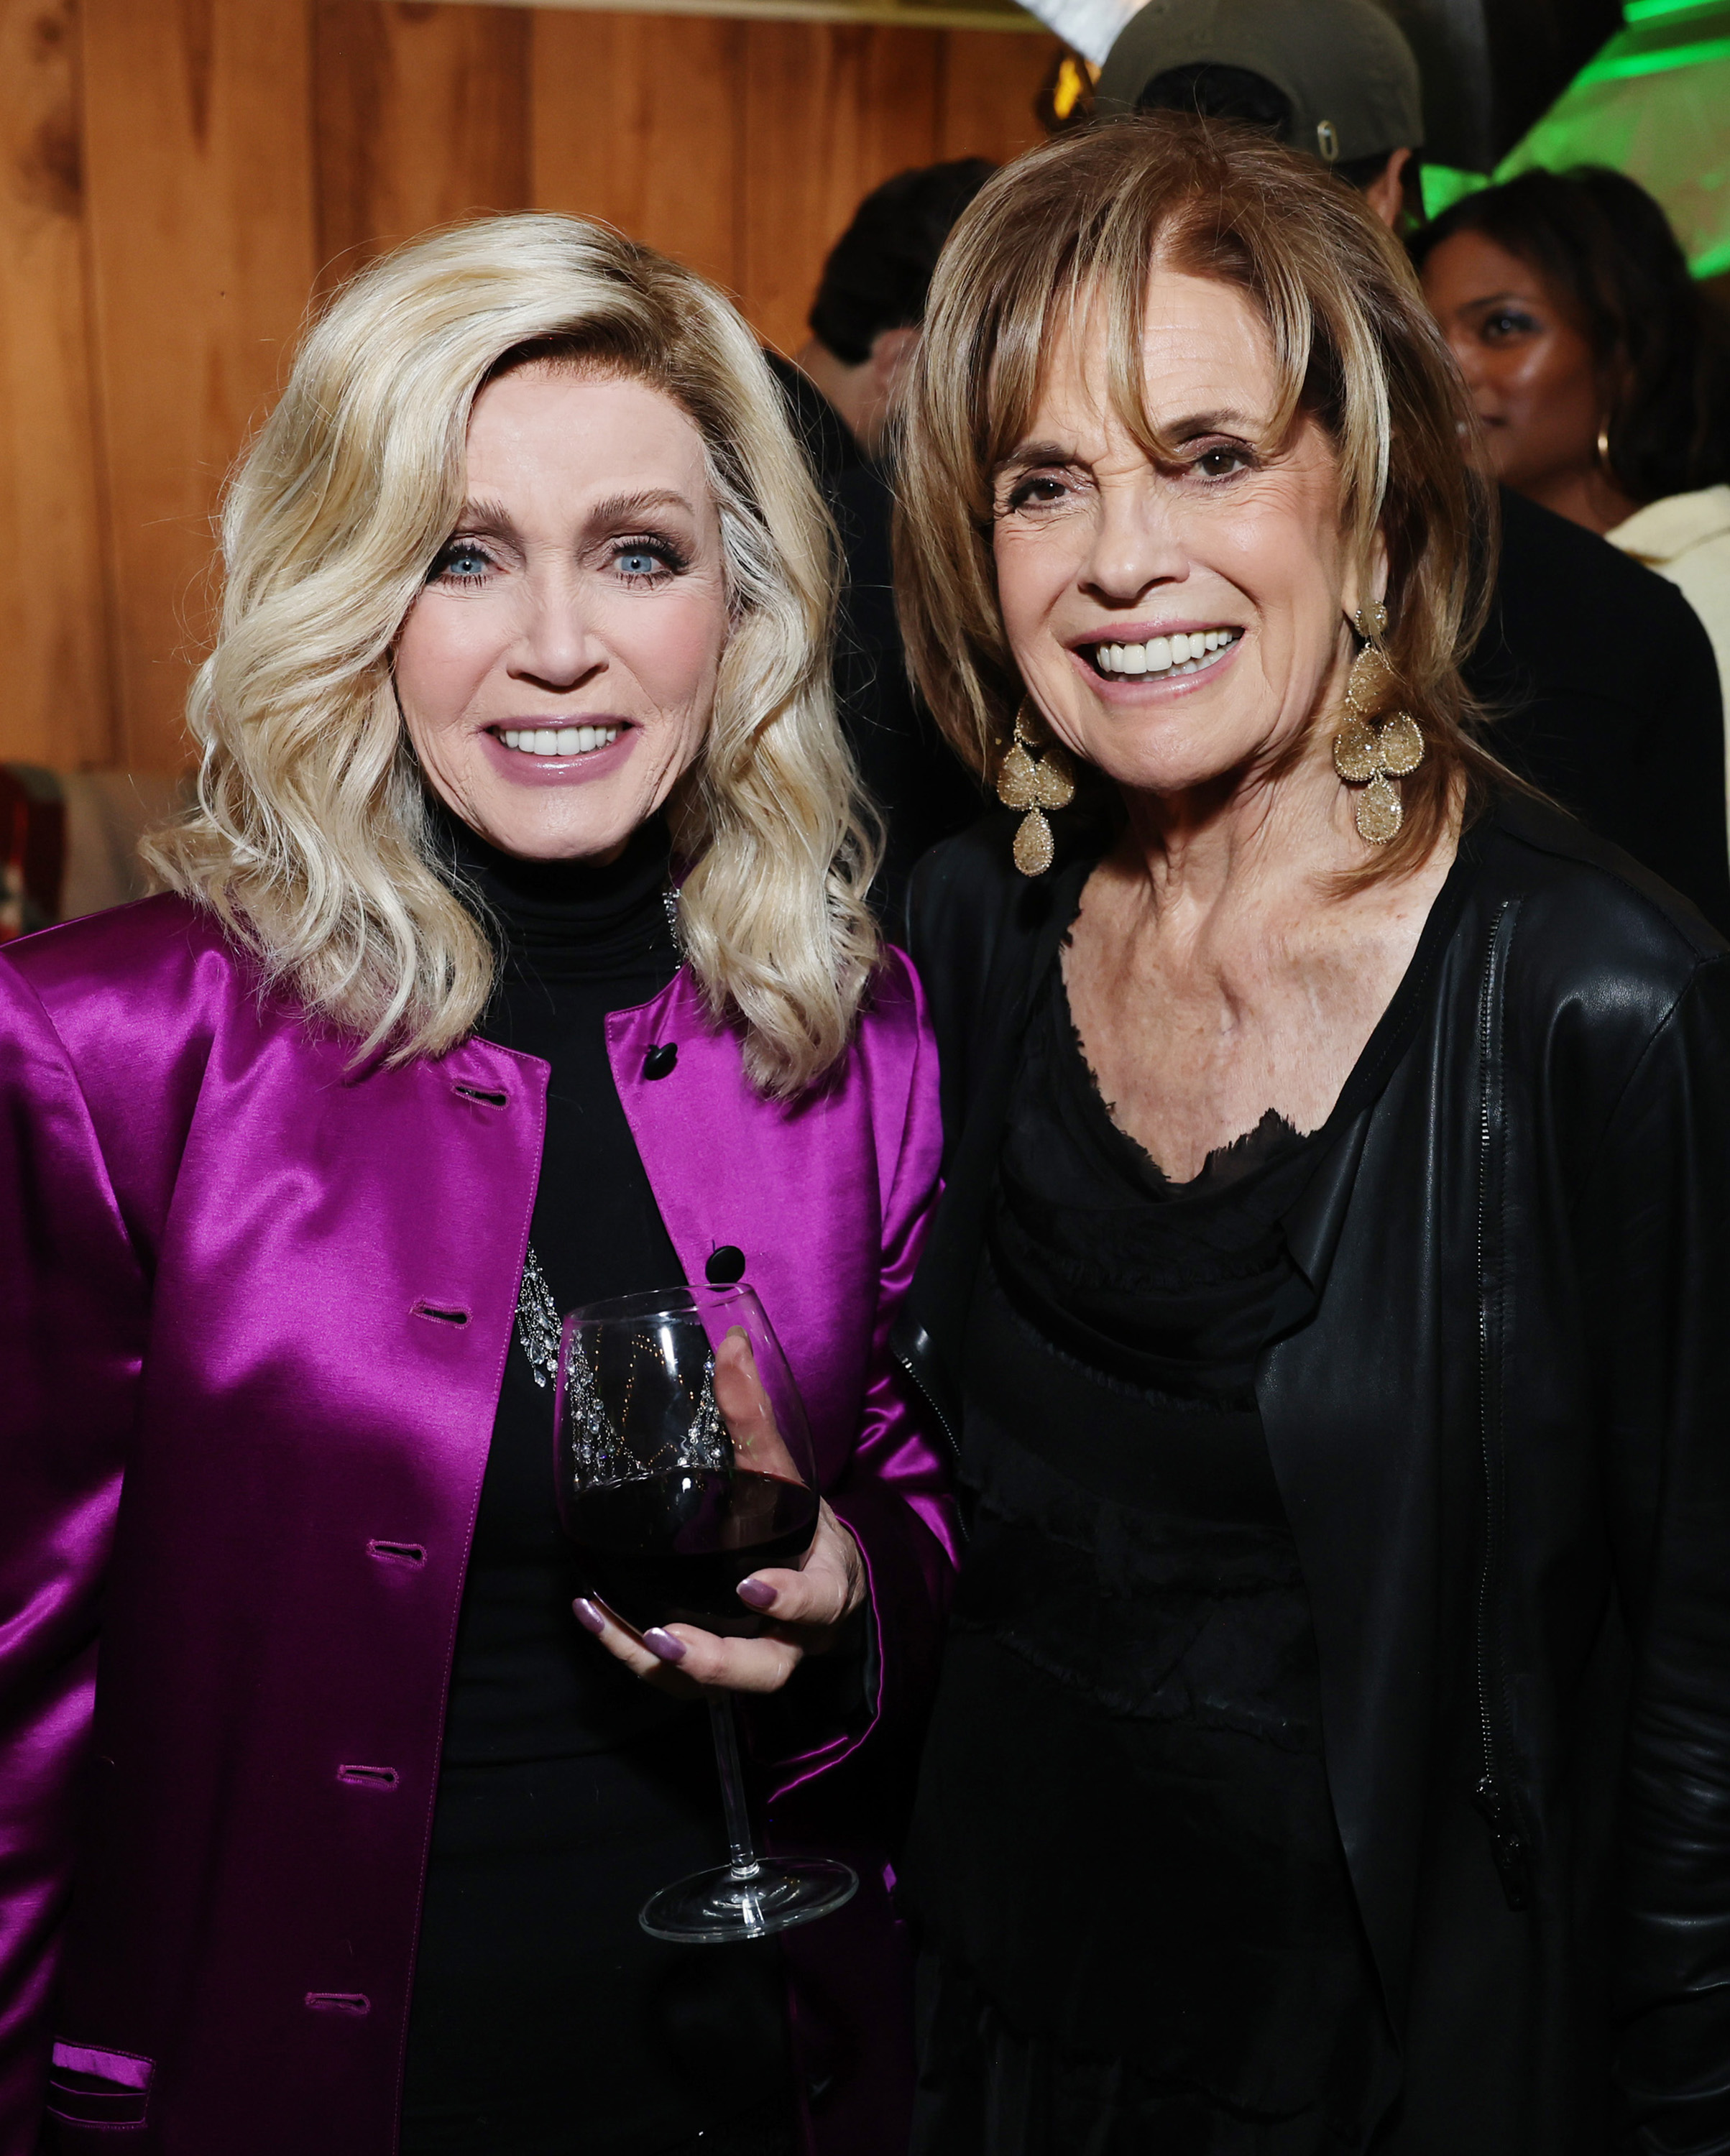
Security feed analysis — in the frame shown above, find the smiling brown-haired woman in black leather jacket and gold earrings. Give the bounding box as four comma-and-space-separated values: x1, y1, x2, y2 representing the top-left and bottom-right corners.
898, 116, 1730, 2156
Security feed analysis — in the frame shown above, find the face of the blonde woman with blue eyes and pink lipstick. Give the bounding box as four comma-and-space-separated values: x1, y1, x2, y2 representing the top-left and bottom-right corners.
397, 367, 727, 860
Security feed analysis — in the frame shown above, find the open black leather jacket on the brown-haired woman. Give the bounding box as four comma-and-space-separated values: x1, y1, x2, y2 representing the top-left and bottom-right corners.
898, 802, 1730, 2156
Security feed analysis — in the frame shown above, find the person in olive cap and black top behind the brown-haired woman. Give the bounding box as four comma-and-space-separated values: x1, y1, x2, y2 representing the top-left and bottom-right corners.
1094, 0, 1730, 931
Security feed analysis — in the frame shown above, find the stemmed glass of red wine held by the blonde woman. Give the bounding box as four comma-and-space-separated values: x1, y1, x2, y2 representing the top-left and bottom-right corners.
554, 1285, 858, 1943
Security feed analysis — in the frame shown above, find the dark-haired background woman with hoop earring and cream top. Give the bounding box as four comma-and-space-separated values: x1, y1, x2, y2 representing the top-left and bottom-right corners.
1413, 166, 1730, 763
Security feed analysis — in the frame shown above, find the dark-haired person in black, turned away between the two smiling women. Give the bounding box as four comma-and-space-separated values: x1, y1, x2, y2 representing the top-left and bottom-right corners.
770, 157, 995, 923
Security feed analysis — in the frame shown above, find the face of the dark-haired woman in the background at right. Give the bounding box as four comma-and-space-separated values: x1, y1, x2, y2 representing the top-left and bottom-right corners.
1424, 233, 1605, 496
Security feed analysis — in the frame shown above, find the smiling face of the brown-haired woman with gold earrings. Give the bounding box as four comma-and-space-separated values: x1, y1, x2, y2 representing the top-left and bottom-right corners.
995, 272, 1361, 793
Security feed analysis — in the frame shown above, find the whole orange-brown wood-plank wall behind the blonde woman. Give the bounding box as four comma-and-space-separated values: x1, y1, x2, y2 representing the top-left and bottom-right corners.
0, 0, 1053, 772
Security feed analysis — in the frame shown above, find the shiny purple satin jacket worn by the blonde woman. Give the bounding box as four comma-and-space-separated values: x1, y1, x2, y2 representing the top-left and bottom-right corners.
0, 899, 952, 2156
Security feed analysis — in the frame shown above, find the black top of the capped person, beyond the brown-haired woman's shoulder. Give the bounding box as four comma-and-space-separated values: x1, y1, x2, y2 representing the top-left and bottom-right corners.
1465, 487, 1730, 931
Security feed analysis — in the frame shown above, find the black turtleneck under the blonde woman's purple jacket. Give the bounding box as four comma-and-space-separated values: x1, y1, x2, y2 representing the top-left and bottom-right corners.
401, 817, 791, 2156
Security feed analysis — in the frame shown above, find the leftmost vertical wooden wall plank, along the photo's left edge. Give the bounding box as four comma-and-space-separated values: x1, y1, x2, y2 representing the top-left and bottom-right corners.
0, 0, 116, 770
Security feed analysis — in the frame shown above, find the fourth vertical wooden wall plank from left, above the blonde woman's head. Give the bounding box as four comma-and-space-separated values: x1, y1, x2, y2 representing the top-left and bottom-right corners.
530, 9, 750, 293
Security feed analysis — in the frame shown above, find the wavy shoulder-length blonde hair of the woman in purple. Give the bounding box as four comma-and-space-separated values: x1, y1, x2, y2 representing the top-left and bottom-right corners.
147, 216, 878, 1097
